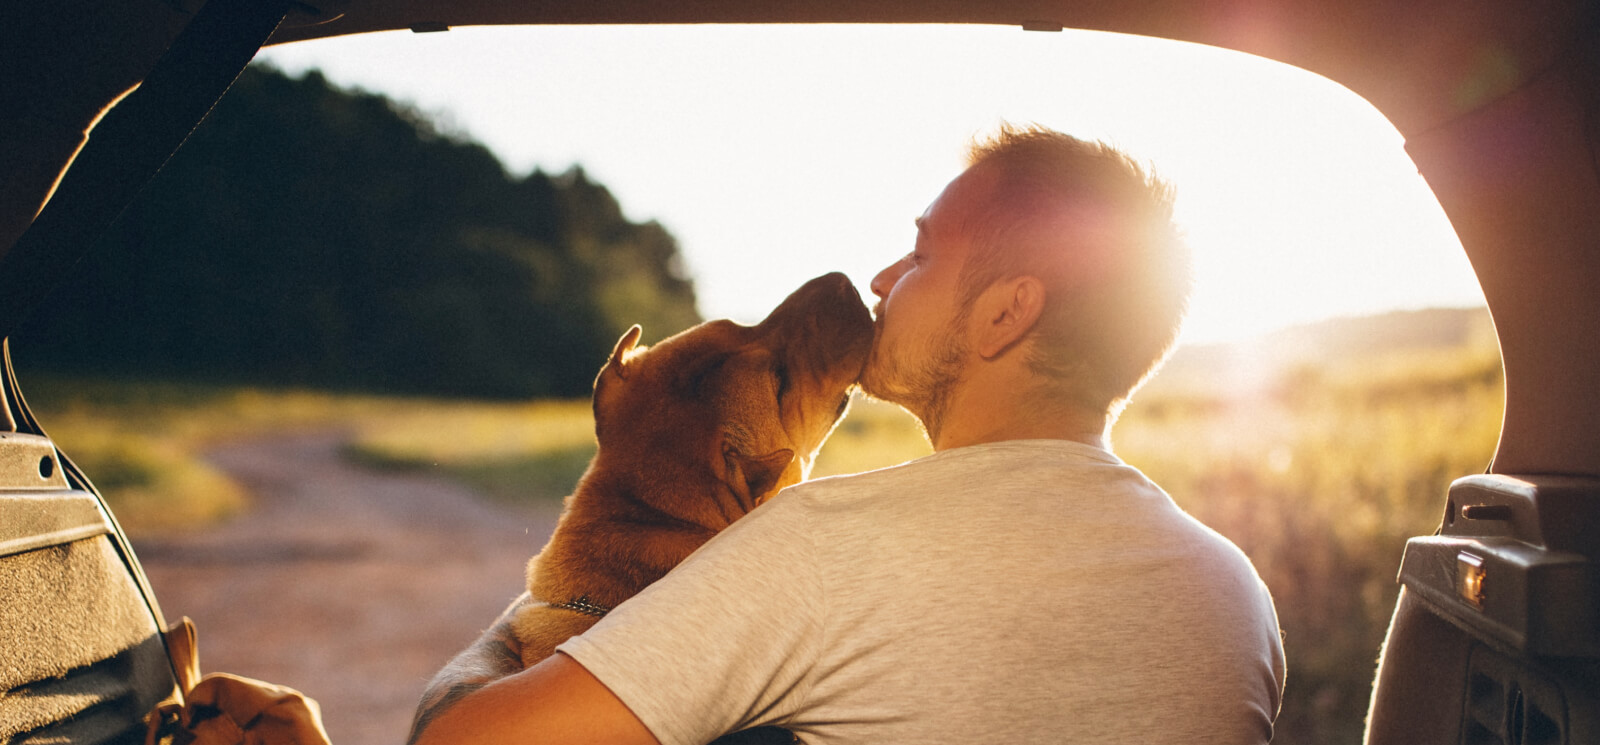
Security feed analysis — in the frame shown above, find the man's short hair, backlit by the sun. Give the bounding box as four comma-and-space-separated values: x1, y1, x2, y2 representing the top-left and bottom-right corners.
962, 125, 1194, 414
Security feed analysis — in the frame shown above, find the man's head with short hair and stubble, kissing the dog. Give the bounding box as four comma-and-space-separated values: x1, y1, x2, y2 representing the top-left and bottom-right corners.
862, 126, 1192, 433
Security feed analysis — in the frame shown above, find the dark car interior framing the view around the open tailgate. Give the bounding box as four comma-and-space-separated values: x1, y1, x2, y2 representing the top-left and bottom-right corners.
9, 0, 1600, 743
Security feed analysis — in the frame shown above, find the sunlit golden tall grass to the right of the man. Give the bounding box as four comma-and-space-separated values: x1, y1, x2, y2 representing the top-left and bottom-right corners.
1114, 349, 1504, 745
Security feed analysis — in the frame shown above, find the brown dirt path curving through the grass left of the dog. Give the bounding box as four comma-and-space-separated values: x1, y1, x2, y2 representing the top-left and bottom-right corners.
134, 433, 557, 745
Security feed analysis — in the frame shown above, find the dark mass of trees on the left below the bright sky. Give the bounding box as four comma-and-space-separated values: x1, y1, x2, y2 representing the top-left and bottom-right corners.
13, 66, 699, 396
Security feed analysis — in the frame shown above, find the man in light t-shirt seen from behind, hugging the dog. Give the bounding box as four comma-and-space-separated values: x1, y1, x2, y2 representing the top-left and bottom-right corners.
419, 128, 1285, 745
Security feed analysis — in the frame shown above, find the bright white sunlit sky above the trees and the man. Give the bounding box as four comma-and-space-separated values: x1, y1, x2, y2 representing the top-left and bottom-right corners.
259, 26, 1483, 344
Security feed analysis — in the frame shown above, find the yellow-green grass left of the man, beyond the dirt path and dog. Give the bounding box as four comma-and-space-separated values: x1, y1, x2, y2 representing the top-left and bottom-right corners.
15, 377, 931, 531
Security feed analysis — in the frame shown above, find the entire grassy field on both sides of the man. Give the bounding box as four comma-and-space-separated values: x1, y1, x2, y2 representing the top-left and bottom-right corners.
22, 319, 1502, 745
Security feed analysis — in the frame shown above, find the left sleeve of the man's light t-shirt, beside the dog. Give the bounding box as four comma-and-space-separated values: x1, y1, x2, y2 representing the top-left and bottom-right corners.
557, 492, 824, 745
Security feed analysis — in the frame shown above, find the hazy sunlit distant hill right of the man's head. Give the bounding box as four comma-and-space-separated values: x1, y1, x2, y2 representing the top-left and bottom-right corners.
1144, 307, 1498, 395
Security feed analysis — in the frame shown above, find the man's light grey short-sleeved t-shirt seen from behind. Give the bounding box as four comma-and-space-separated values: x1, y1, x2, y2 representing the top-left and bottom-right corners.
560, 440, 1285, 745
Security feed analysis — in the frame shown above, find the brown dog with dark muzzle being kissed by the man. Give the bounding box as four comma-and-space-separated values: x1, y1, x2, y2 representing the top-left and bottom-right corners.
512, 272, 874, 743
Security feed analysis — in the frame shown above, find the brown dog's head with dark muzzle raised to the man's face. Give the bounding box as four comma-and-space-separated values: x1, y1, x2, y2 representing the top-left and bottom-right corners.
590, 273, 872, 528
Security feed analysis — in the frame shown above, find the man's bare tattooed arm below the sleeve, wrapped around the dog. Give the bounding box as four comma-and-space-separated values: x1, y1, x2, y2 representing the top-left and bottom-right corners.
408, 593, 659, 745
